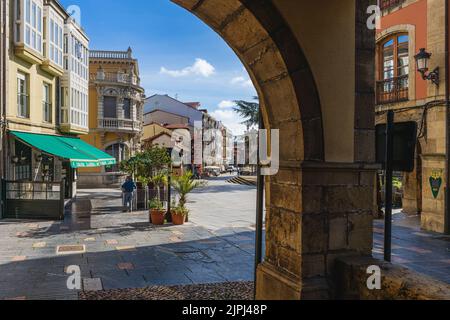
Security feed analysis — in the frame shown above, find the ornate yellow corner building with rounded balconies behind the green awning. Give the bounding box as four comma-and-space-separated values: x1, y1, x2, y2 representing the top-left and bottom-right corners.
79, 48, 145, 187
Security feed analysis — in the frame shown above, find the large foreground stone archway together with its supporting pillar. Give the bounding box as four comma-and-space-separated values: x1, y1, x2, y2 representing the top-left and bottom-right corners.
171, 0, 376, 299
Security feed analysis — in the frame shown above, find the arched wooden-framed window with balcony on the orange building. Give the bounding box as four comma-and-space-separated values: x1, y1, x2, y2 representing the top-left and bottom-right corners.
377, 34, 410, 104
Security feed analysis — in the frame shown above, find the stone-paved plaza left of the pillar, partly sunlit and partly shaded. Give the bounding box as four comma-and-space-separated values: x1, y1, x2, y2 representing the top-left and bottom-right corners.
0, 179, 256, 299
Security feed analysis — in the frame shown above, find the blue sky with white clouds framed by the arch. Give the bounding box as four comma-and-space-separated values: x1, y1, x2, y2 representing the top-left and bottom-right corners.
61, 0, 256, 134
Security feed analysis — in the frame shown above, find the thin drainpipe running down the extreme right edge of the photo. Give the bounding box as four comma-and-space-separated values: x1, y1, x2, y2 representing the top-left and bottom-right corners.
444, 0, 450, 234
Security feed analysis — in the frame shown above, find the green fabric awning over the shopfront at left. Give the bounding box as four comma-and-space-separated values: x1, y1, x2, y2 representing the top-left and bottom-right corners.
10, 131, 116, 169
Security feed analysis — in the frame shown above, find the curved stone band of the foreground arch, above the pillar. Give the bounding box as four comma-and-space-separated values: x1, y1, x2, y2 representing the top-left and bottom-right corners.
173, 0, 324, 161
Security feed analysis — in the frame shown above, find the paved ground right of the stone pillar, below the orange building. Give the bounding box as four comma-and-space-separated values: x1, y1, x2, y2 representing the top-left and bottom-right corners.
373, 212, 450, 283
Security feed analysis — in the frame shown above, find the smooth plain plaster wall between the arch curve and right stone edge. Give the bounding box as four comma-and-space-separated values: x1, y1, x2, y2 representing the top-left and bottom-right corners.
273, 0, 356, 162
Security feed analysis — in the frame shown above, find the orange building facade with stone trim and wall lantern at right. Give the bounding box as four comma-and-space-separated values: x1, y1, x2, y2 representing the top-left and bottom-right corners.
375, 0, 448, 233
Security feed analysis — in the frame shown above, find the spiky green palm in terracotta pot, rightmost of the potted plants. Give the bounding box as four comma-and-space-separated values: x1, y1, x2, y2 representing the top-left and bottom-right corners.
172, 171, 206, 222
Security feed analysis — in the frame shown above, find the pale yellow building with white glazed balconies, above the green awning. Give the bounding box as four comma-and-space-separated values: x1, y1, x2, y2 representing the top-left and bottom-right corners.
2, 0, 89, 198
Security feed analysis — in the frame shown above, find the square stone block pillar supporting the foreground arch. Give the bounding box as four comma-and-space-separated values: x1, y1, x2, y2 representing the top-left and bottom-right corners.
257, 162, 376, 300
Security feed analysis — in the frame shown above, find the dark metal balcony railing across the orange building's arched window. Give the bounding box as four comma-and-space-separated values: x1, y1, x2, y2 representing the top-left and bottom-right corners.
376, 75, 409, 104
